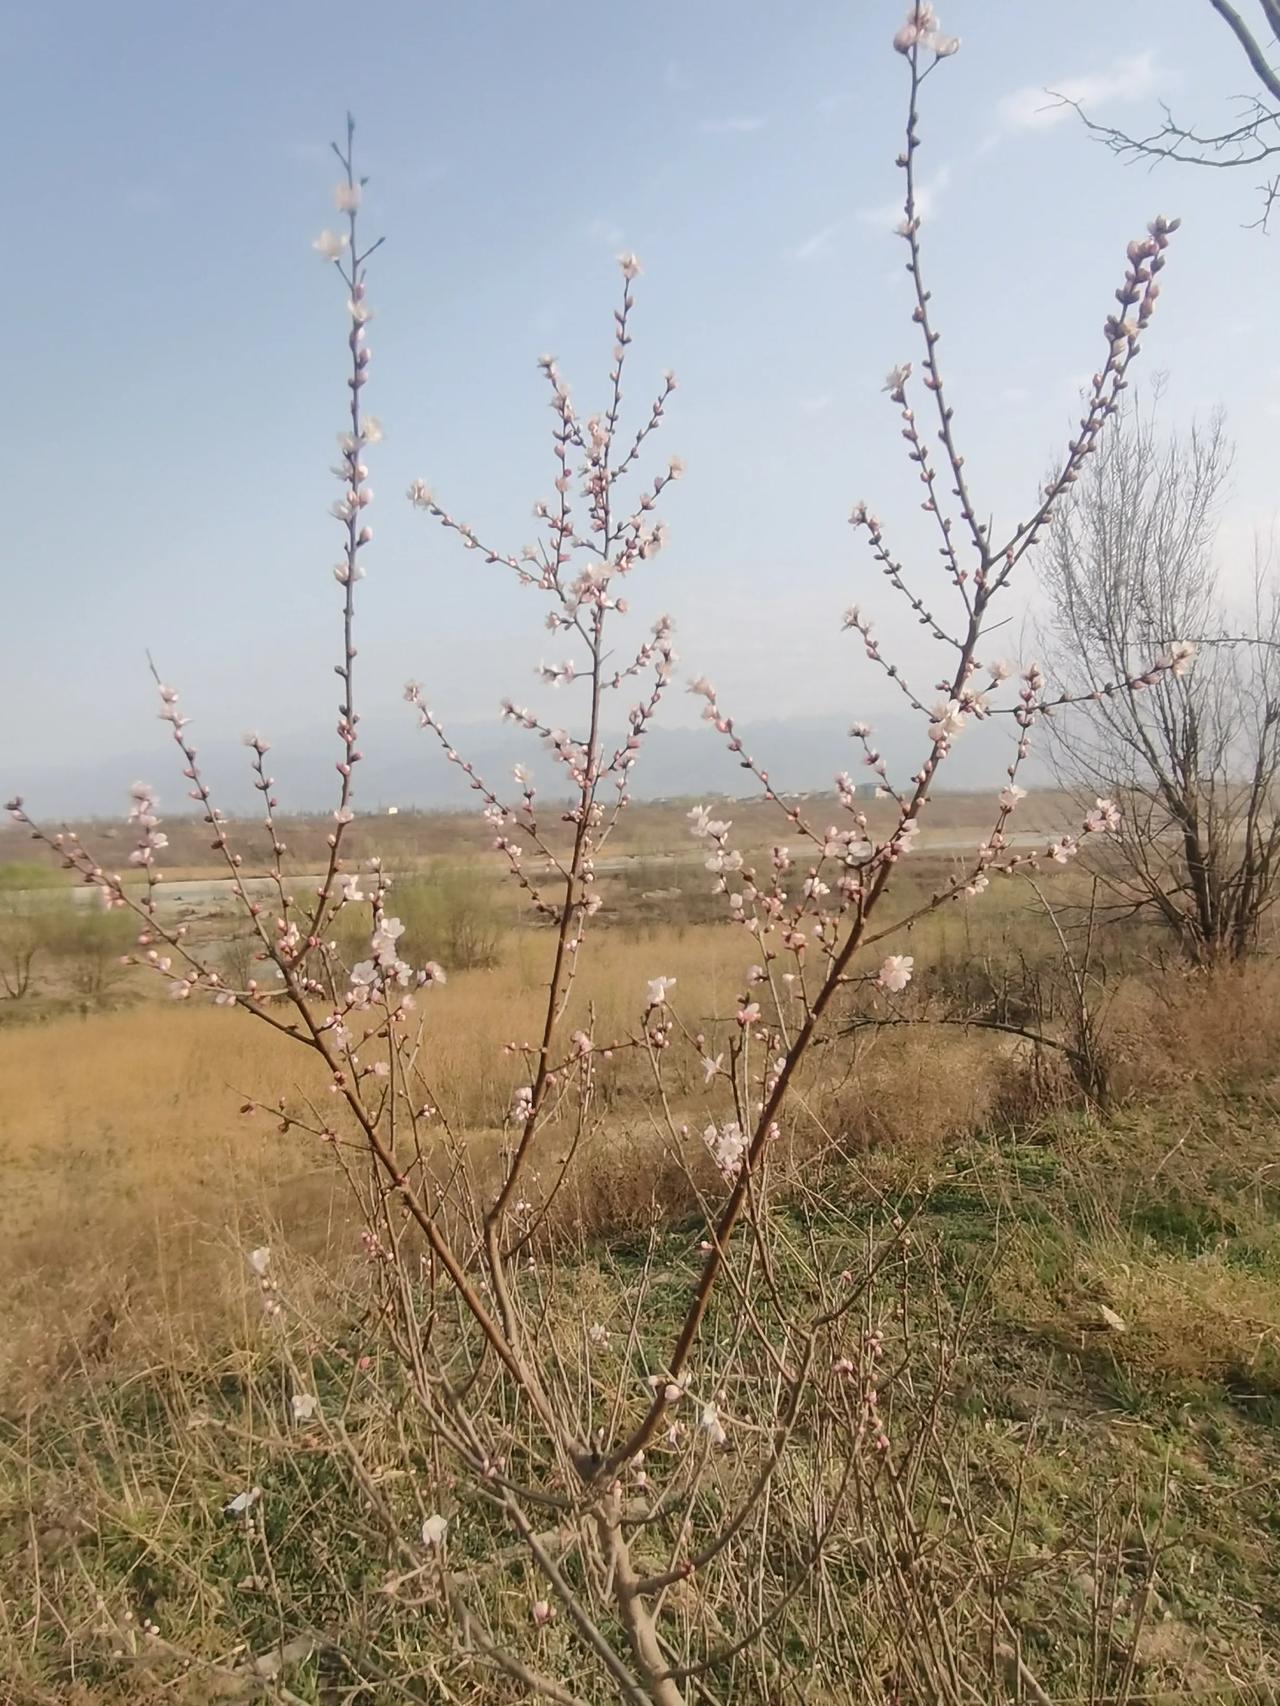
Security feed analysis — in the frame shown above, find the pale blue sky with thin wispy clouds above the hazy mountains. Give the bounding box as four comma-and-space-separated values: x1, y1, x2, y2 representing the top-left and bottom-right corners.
12, 0, 1280, 804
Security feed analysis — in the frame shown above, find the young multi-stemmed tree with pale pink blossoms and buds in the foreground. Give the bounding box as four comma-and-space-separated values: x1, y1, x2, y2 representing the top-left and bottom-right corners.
10, 3, 1201, 1706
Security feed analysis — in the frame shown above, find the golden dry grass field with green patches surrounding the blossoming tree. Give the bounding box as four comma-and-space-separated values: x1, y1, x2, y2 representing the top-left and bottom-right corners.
0, 791, 1280, 1706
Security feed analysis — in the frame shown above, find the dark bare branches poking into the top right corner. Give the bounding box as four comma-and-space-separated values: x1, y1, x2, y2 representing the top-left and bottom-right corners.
1072, 0, 1280, 230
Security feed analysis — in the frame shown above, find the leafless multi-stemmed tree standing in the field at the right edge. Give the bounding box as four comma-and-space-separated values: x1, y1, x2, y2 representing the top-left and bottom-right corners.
1046, 392, 1280, 962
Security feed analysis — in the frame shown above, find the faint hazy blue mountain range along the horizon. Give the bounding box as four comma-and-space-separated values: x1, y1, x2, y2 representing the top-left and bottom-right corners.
5, 717, 1048, 819
